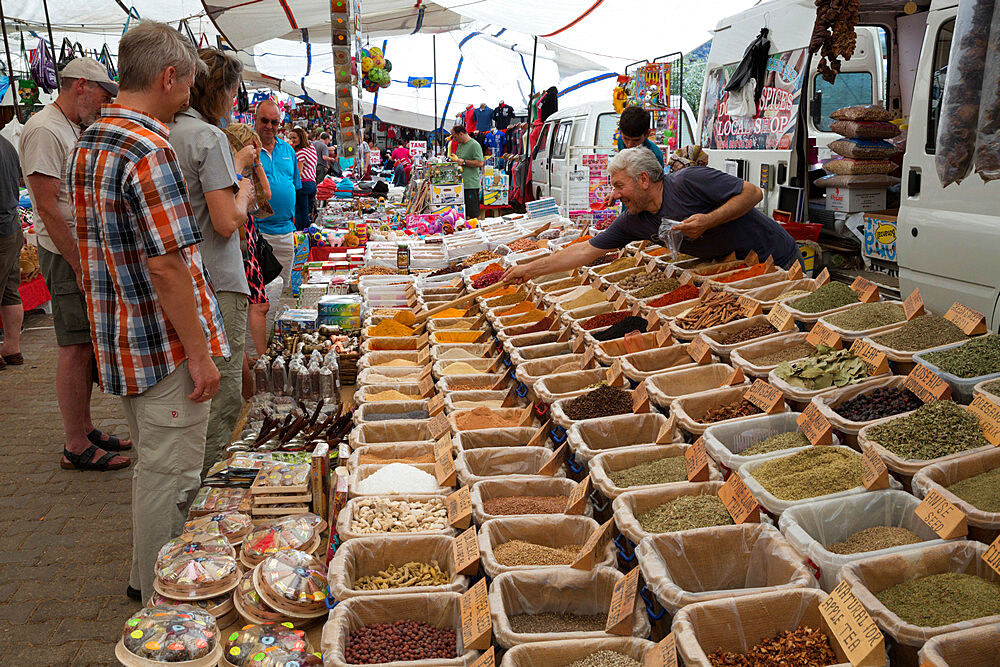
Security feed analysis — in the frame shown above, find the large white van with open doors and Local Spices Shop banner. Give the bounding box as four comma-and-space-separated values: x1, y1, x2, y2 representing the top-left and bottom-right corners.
697, 0, 1000, 327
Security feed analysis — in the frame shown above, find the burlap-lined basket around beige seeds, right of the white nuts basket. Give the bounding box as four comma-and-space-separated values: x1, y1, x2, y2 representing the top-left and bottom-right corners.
479, 514, 618, 579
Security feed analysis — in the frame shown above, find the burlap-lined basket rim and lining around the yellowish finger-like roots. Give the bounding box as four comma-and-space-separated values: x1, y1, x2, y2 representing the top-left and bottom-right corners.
329, 535, 469, 602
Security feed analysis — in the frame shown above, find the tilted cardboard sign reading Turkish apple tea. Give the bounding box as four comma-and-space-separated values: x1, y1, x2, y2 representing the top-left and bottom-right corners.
819, 581, 885, 667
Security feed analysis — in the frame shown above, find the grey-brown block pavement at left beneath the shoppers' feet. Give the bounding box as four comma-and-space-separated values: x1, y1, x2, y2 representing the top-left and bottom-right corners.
0, 312, 140, 667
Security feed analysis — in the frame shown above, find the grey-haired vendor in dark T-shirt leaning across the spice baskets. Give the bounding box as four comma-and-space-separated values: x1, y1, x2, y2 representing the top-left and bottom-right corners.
504, 147, 799, 282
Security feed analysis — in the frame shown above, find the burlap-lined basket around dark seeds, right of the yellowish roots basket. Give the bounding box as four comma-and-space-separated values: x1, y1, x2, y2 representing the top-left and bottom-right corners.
490, 567, 650, 648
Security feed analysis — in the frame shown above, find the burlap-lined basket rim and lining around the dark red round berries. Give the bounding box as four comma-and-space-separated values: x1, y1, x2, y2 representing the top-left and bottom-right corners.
321, 593, 479, 667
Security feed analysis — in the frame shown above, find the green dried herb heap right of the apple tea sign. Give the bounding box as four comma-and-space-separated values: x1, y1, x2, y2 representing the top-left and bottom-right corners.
875, 572, 1000, 628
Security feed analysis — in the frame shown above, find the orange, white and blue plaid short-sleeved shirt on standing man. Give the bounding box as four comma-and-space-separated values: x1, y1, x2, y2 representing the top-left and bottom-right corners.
66, 104, 229, 396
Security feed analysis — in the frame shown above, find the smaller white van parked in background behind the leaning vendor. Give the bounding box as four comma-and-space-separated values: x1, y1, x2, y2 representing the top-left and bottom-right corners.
531, 100, 694, 205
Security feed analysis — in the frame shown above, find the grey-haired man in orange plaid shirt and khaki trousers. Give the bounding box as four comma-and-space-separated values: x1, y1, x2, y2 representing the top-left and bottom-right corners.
66, 21, 229, 599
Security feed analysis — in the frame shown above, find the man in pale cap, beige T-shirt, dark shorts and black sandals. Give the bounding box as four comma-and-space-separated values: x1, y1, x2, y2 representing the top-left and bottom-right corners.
18, 58, 132, 470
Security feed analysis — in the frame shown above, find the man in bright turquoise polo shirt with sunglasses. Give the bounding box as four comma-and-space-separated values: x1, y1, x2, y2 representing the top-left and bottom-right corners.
254, 99, 302, 289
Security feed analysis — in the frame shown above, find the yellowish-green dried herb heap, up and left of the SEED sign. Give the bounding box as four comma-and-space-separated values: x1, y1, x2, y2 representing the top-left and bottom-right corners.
751, 447, 862, 500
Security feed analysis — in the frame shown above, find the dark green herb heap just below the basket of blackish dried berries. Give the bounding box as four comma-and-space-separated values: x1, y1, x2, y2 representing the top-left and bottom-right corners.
868, 401, 990, 461
